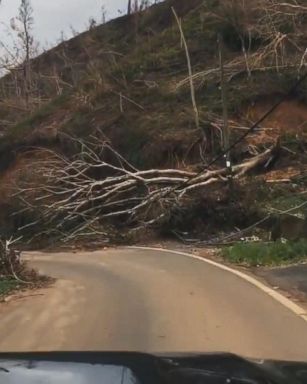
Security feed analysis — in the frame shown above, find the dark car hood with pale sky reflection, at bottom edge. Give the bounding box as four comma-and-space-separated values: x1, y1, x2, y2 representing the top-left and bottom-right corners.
0, 352, 307, 384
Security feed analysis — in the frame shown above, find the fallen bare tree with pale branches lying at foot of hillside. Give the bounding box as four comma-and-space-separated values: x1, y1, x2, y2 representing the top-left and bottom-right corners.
15, 139, 276, 241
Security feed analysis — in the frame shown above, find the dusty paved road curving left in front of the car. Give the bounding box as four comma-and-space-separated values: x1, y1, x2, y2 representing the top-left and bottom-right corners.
0, 249, 307, 361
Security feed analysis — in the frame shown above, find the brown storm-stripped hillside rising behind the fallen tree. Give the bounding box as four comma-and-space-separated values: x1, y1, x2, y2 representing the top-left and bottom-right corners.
0, 0, 307, 246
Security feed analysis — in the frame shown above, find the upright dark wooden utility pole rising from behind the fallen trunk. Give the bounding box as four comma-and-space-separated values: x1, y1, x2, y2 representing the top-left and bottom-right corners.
218, 35, 232, 175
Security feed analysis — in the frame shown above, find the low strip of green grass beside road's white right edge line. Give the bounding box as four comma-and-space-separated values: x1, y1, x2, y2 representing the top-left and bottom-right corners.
221, 239, 307, 267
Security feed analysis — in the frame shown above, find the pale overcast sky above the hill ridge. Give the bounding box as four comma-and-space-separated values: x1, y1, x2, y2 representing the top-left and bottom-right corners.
0, 0, 127, 48
